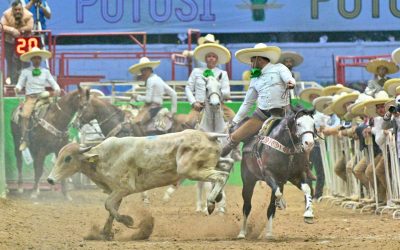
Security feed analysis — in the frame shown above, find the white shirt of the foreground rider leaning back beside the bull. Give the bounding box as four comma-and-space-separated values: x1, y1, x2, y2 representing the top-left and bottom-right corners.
233, 63, 296, 123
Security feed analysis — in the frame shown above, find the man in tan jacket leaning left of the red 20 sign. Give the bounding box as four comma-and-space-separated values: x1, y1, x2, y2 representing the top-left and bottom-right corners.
0, 0, 33, 84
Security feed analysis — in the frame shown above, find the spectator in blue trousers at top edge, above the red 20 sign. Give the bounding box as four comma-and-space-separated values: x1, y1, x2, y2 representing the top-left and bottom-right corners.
25, 0, 51, 30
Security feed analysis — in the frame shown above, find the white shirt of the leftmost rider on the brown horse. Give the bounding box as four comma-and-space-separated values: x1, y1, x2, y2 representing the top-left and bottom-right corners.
15, 66, 60, 95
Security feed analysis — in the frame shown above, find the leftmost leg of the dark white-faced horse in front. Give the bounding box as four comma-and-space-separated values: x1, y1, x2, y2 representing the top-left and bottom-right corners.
237, 156, 257, 239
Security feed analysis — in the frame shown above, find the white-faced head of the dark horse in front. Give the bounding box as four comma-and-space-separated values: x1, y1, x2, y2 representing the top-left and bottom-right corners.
288, 109, 315, 153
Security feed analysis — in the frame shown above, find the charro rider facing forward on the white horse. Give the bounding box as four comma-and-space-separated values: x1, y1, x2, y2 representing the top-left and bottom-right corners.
185, 39, 235, 120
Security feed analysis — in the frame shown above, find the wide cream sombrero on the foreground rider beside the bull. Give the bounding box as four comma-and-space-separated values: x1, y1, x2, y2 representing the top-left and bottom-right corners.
235, 43, 281, 64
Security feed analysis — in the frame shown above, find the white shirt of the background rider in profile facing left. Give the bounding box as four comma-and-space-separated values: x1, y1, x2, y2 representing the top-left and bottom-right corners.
137, 74, 177, 113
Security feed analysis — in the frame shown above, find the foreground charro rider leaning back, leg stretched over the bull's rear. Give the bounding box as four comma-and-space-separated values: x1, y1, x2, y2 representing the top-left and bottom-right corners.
221, 43, 296, 156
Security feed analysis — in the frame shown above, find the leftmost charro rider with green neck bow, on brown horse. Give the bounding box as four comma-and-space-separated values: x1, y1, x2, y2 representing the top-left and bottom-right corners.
15, 48, 60, 150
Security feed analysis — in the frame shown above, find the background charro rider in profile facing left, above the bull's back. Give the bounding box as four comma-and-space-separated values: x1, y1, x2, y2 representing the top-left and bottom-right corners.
129, 57, 177, 129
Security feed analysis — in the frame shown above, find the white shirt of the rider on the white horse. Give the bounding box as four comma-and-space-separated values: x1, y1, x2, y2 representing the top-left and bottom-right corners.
185, 68, 231, 104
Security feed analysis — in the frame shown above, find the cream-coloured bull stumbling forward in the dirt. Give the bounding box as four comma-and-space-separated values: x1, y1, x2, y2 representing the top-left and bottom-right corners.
47, 130, 229, 239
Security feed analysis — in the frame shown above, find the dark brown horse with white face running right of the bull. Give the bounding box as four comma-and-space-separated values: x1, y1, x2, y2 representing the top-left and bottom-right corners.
237, 110, 315, 239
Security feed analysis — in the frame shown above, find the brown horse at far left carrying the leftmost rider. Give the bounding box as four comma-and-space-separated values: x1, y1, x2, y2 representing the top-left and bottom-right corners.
11, 87, 88, 200
